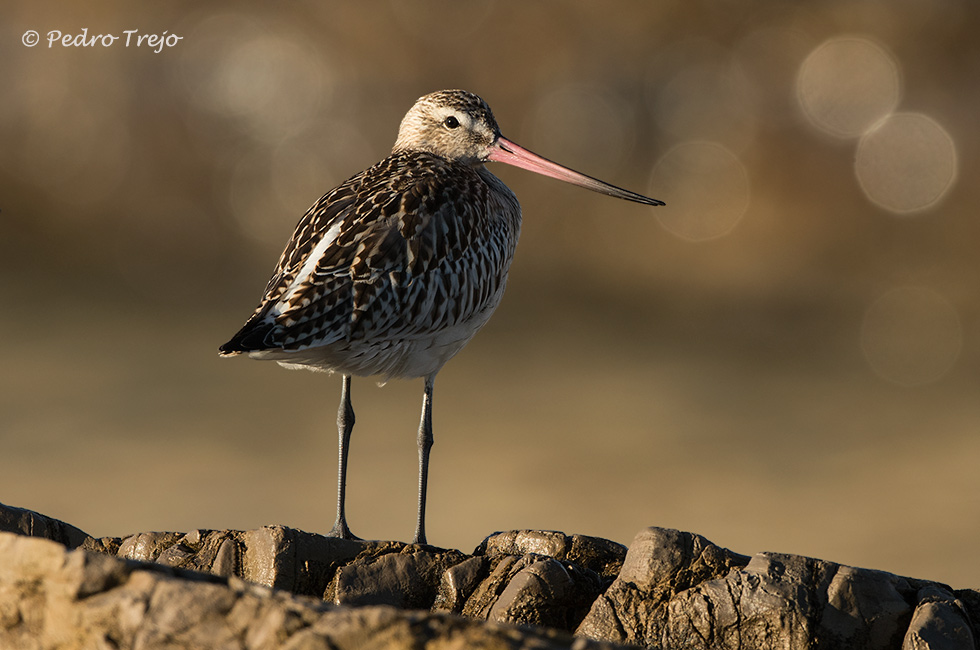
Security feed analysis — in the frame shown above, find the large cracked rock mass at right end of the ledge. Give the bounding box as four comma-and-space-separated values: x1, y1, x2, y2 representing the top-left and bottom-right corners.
577, 528, 975, 650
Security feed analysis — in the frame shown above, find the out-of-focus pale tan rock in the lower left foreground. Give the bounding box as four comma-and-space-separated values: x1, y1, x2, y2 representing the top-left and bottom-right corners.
0, 533, 613, 650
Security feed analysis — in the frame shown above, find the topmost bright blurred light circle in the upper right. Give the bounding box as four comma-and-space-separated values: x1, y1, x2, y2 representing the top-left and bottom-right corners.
796, 36, 902, 138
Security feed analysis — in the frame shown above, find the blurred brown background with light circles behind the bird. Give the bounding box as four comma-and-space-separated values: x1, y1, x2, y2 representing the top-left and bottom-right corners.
0, 0, 980, 587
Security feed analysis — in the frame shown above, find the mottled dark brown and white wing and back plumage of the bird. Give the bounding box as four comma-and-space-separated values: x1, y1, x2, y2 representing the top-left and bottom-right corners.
221, 152, 516, 353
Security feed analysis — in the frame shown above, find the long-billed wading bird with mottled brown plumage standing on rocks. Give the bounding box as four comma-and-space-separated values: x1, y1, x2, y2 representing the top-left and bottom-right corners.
219, 90, 664, 544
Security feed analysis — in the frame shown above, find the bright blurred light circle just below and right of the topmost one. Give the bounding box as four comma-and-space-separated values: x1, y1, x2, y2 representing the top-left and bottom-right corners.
854, 113, 958, 213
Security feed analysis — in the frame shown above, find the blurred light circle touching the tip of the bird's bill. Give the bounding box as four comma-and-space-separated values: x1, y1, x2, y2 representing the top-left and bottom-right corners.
649, 141, 749, 241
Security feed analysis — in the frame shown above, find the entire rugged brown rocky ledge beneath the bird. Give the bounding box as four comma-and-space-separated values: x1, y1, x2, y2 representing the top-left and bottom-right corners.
0, 504, 980, 650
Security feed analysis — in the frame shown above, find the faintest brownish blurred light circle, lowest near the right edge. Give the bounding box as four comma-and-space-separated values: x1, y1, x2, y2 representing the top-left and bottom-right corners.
861, 287, 963, 386
